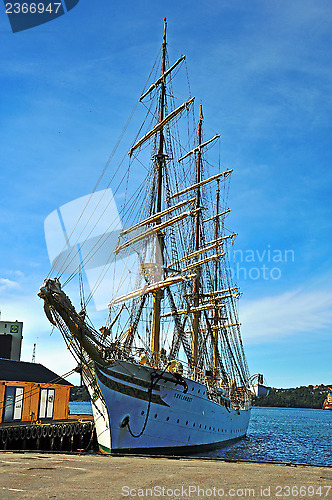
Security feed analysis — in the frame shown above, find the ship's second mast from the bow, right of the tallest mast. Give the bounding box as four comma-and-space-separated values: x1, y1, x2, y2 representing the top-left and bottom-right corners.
192, 105, 203, 367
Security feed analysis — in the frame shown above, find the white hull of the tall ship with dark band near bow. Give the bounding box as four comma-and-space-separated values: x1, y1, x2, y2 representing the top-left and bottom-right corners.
85, 361, 250, 455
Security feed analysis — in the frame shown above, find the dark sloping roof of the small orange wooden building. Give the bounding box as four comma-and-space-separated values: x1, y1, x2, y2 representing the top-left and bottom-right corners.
0, 359, 72, 385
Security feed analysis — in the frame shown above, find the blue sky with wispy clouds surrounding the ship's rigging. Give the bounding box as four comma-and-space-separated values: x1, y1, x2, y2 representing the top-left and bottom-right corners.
0, 0, 332, 387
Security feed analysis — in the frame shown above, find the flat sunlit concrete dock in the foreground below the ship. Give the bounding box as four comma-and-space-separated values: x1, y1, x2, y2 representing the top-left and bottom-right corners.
0, 452, 332, 500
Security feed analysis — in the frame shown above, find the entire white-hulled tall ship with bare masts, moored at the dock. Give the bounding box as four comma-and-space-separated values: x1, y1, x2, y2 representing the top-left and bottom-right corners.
38, 20, 259, 454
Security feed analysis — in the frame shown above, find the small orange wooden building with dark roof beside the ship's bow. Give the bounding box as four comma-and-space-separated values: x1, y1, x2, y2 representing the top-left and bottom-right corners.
0, 359, 72, 423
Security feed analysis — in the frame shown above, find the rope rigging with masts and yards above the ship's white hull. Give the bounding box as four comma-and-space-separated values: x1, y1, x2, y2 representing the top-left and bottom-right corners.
40, 24, 249, 422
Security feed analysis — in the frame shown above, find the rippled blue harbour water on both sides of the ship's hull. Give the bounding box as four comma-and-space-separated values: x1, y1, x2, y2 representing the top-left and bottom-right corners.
69, 403, 332, 467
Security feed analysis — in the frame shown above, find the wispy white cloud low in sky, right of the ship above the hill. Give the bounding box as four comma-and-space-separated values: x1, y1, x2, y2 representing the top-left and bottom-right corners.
240, 288, 332, 343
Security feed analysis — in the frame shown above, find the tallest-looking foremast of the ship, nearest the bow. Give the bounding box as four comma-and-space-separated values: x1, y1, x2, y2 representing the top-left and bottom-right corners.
151, 18, 167, 365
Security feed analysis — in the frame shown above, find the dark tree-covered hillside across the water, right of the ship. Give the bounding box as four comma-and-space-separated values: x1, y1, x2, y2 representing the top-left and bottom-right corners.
253, 385, 331, 408
